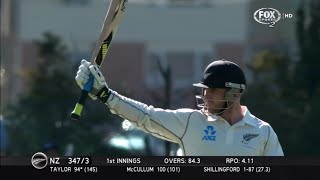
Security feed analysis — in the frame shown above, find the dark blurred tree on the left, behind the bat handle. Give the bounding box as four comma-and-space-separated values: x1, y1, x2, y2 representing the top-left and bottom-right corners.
5, 33, 126, 155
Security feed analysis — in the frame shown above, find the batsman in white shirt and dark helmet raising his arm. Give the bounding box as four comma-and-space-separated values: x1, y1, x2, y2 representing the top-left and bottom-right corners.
75, 60, 284, 156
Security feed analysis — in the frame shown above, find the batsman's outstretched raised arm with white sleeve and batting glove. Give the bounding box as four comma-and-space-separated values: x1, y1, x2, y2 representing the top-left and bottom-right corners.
76, 60, 190, 144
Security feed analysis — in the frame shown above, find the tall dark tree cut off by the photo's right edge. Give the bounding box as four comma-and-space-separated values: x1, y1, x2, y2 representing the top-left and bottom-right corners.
293, 0, 320, 155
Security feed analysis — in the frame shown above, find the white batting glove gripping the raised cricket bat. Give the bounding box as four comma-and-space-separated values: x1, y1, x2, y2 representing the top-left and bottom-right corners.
75, 59, 110, 102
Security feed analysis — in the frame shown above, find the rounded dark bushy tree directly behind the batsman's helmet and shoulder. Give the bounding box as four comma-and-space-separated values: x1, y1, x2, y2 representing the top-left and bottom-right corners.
243, 51, 302, 154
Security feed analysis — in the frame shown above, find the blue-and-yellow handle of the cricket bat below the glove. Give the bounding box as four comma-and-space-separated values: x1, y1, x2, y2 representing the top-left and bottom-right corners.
70, 74, 94, 120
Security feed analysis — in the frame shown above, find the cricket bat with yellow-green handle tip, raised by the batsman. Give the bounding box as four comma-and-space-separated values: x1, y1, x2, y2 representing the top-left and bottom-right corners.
71, 0, 128, 120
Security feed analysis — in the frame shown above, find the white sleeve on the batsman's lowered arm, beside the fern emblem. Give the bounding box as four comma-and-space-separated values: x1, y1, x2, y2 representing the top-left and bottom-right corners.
264, 126, 284, 156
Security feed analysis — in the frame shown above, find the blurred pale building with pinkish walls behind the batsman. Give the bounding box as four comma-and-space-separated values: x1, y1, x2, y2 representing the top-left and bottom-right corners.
1, 0, 316, 153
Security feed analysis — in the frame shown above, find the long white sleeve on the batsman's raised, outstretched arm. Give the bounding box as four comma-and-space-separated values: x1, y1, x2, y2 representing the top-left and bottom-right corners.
105, 90, 191, 143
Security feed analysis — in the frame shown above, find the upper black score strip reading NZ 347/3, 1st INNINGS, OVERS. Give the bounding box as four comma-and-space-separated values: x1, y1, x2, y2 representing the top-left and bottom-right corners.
1, 156, 320, 166
